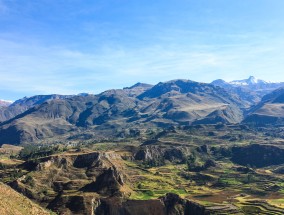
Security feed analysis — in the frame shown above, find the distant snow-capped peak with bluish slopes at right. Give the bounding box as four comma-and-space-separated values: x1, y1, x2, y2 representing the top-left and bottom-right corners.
211, 76, 284, 108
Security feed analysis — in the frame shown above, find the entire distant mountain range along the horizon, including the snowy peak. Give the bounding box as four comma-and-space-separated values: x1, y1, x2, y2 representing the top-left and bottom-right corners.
0, 76, 284, 145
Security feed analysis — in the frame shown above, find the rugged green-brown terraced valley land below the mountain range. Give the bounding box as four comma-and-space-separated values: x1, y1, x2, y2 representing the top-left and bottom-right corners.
0, 124, 284, 215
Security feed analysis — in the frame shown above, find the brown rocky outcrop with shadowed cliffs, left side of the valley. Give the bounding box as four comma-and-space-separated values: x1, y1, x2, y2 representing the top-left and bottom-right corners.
10, 152, 127, 214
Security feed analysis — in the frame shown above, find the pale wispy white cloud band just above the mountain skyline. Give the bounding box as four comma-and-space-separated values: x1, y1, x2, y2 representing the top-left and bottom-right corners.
0, 28, 284, 100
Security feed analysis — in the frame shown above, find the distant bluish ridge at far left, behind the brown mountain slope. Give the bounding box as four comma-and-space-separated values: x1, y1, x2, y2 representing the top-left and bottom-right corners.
0, 94, 71, 122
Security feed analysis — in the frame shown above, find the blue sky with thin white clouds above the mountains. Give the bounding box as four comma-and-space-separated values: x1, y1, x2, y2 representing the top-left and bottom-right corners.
0, 0, 284, 100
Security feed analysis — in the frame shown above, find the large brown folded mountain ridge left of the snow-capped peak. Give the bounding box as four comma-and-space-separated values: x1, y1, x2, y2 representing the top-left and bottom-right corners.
0, 80, 245, 144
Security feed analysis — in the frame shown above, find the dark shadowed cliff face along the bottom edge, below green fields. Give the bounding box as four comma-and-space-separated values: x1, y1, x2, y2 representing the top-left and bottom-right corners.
94, 193, 241, 215
